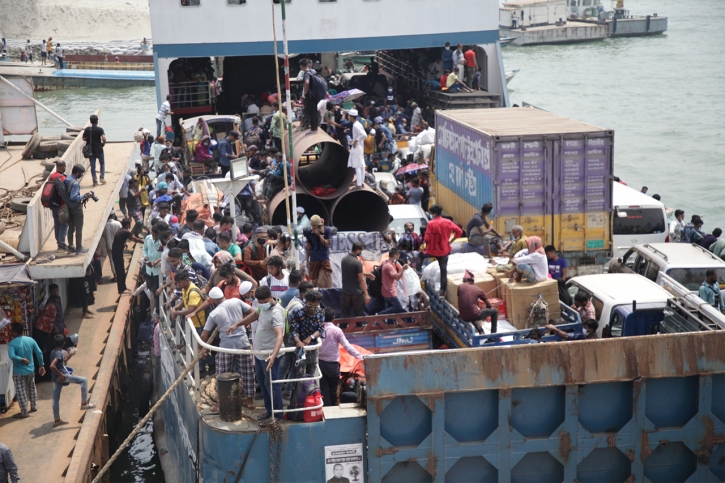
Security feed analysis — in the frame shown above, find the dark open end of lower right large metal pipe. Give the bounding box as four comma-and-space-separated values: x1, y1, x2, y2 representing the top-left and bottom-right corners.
330, 185, 390, 232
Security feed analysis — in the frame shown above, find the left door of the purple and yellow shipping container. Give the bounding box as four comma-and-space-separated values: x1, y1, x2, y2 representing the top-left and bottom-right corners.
494, 138, 552, 244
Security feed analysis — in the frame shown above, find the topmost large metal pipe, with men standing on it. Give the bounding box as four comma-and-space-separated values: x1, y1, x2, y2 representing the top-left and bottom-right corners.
292, 130, 355, 200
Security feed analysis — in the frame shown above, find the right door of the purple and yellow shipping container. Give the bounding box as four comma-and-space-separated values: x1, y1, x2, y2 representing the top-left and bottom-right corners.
552, 135, 612, 257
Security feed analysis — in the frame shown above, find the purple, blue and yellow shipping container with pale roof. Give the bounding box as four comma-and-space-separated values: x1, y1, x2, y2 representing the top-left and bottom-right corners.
434, 108, 614, 276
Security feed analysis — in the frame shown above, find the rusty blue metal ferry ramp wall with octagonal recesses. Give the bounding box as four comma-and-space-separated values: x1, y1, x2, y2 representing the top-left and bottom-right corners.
366, 334, 725, 483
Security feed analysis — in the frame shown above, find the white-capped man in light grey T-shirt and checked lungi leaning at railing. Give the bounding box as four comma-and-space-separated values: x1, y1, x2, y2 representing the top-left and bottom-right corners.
201, 281, 254, 409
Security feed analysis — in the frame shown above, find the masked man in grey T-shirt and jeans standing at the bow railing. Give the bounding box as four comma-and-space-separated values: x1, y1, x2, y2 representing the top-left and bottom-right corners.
227, 287, 285, 421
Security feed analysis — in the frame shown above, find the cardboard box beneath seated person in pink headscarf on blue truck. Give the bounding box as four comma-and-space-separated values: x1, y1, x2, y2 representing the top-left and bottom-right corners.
499, 279, 561, 330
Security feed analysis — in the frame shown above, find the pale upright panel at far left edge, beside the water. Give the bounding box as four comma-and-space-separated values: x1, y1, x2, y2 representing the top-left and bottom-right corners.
0, 77, 38, 137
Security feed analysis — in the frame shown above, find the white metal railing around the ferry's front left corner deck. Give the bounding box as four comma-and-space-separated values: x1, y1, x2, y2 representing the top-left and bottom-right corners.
158, 291, 324, 416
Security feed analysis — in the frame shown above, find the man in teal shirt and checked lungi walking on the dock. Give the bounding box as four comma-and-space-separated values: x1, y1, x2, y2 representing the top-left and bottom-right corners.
8, 322, 45, 419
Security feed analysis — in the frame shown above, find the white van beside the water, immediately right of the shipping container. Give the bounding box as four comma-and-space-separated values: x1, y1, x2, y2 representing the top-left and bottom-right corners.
612, 181, 670, 260
